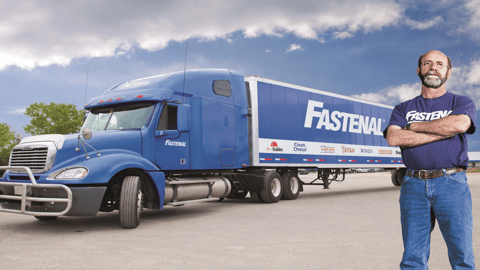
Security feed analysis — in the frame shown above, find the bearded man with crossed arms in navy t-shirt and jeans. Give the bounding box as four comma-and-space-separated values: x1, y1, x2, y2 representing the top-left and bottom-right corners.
385, 51, 476, 269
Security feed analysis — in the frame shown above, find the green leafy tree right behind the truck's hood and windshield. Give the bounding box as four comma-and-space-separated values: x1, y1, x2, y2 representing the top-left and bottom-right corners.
23, 102, 83, 135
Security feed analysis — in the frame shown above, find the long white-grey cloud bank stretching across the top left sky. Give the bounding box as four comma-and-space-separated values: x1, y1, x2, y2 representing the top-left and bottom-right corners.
0, 0, 404, 70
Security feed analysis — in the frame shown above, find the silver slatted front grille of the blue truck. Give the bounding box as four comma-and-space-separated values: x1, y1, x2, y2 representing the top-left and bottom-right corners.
10, 146, 48, 171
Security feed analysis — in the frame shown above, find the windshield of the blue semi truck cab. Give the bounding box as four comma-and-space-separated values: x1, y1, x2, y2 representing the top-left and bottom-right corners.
82, 104, 155, 131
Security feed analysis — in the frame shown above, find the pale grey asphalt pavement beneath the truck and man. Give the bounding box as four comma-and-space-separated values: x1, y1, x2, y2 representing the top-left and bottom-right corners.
0, 172, 480, 270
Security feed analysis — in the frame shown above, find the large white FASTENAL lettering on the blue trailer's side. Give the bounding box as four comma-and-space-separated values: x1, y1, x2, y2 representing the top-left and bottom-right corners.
303, 100, 385, 136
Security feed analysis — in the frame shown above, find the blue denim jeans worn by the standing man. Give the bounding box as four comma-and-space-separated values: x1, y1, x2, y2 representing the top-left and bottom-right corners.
400, 170, 475, 269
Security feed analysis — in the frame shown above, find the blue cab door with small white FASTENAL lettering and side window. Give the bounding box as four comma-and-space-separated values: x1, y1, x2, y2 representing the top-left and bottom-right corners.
154, 103, 190, 171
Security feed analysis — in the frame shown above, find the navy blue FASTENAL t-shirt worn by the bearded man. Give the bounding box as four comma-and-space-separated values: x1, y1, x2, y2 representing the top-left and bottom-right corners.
387, 92, 476, 170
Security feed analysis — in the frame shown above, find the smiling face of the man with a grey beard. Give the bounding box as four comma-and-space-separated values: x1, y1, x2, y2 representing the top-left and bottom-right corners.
417, 52, 451, 89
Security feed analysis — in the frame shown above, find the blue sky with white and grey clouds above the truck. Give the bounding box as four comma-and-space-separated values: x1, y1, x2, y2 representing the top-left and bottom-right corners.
0, 0, 480, 151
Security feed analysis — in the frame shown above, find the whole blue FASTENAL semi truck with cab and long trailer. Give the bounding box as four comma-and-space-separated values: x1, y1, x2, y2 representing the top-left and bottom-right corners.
0, 69, 403, 228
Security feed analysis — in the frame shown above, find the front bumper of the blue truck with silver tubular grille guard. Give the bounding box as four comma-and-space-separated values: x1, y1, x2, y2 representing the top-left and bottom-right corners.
0, 167, 107, 216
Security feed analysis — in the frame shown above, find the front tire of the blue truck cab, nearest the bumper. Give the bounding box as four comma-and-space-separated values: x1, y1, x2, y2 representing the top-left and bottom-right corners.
119, 176, 143, 229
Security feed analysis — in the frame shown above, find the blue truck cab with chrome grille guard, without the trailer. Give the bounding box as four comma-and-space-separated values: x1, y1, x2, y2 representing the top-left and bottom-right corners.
0, 70, 249, 228
